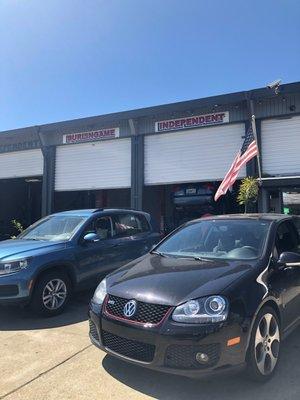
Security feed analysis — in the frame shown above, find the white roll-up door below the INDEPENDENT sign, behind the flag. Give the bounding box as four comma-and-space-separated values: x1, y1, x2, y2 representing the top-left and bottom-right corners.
145, 124, 245, 185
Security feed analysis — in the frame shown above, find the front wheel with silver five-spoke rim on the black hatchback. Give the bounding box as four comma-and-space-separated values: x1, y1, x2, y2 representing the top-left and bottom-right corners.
247, 306, 281, 382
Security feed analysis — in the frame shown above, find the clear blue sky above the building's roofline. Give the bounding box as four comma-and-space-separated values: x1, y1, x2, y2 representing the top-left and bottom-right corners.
0, 0, 300, 130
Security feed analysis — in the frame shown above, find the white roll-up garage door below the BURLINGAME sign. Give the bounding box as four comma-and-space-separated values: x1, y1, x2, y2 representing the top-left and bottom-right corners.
55, 138, 131, 191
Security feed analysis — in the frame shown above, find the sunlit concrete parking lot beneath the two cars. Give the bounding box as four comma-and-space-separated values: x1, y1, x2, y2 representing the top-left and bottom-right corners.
0, 293, 300, 400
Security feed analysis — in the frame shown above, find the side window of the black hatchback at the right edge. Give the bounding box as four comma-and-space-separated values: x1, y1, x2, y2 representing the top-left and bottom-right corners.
275, 220, 300, 256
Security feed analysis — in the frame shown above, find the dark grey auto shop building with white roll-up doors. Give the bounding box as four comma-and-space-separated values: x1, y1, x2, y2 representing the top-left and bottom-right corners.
0, 82, 300, 237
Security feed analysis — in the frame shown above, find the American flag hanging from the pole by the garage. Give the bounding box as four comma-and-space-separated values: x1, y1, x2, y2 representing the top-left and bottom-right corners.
215, 127, 258, 201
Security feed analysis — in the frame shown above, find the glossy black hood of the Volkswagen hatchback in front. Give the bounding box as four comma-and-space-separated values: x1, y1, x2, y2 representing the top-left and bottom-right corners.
107, 254, 255, 306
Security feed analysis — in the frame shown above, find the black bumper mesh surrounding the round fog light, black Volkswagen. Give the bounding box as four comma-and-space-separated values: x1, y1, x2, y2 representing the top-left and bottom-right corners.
165, 344, 220, 369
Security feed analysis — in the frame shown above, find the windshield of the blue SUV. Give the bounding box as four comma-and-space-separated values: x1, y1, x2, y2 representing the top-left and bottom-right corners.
18, 215, 86, 242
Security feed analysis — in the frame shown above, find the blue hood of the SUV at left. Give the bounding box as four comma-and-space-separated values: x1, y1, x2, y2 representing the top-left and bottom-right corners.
0, 239, 65, 261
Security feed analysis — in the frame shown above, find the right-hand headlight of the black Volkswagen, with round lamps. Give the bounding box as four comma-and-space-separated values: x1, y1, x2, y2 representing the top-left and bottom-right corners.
172, 296, 228, 324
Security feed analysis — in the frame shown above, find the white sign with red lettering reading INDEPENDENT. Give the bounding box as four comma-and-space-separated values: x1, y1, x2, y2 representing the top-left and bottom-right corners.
155, 111, 229, 132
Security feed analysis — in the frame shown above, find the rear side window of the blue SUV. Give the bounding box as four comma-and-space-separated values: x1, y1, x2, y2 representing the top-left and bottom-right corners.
114, 213, 150, 237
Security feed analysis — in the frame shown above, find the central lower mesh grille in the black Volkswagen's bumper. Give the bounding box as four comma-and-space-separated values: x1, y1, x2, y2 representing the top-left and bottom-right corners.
102, 331, 155, 363
